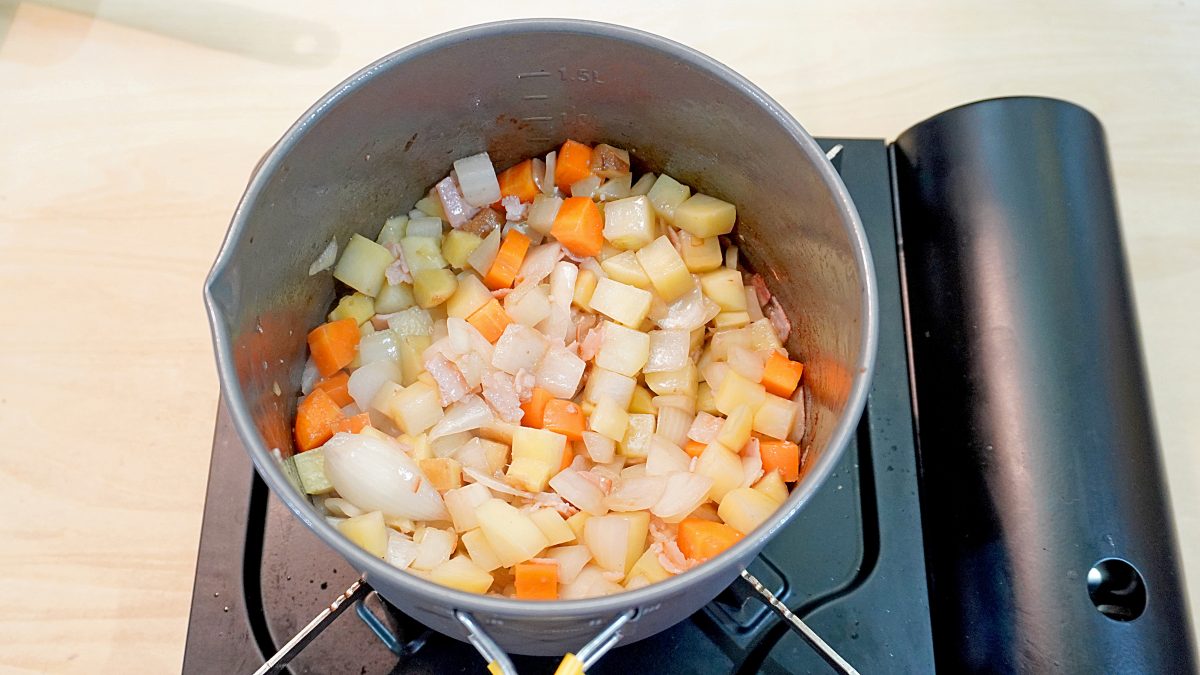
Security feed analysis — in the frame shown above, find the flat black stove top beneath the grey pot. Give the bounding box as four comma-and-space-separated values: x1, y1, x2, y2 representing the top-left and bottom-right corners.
184, 139, 934, 674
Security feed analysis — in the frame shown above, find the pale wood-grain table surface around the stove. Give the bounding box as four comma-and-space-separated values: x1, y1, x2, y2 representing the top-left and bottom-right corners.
0, 0, 1200, 673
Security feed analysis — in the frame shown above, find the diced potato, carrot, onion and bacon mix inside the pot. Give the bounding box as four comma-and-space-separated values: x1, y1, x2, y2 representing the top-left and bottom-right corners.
294, 141, 804, 601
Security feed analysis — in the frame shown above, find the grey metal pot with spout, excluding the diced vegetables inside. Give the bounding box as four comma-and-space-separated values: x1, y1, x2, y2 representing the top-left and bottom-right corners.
205, 19, 876, 655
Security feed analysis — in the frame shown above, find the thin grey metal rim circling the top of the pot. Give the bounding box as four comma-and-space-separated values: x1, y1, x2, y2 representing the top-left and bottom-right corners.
204, 18, 878, 616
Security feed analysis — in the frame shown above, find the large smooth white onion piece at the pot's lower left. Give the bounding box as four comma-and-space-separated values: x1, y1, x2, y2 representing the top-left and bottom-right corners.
324, 432, 449, 520
